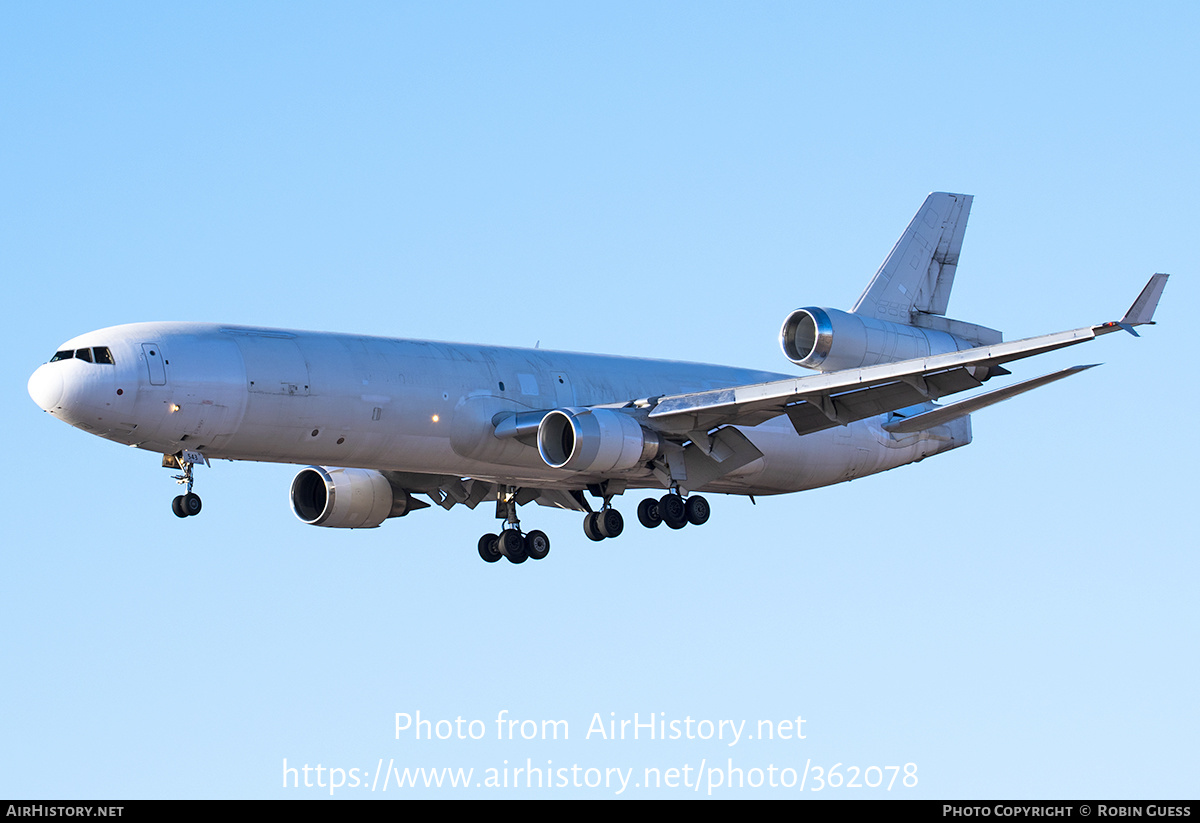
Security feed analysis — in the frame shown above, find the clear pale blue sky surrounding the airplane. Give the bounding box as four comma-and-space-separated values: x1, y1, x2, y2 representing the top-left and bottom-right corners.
0, 2, 1200, 798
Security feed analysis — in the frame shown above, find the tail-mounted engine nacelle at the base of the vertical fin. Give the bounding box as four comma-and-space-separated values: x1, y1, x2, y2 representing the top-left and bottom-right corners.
779, 307, 978, 372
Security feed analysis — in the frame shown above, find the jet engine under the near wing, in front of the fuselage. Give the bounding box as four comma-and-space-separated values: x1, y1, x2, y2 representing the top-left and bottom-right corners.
538, 409, 659, 474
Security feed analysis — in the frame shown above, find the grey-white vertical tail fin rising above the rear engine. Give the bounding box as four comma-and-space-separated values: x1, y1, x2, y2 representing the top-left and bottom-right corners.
851, 192, 974, 324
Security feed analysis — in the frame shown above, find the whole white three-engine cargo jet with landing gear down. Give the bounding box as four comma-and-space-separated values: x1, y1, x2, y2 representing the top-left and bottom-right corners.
29, 192, 1166, 563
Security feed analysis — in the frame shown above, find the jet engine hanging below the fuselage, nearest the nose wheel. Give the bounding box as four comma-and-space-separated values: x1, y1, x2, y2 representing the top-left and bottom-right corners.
290, 465, 408, 529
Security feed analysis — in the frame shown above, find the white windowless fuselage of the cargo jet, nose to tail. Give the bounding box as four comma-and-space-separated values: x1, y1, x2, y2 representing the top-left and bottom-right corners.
23, 323, 971, 494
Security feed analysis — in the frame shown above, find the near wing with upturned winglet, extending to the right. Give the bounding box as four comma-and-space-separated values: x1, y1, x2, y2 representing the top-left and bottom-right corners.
647, 274, 1166, 434
